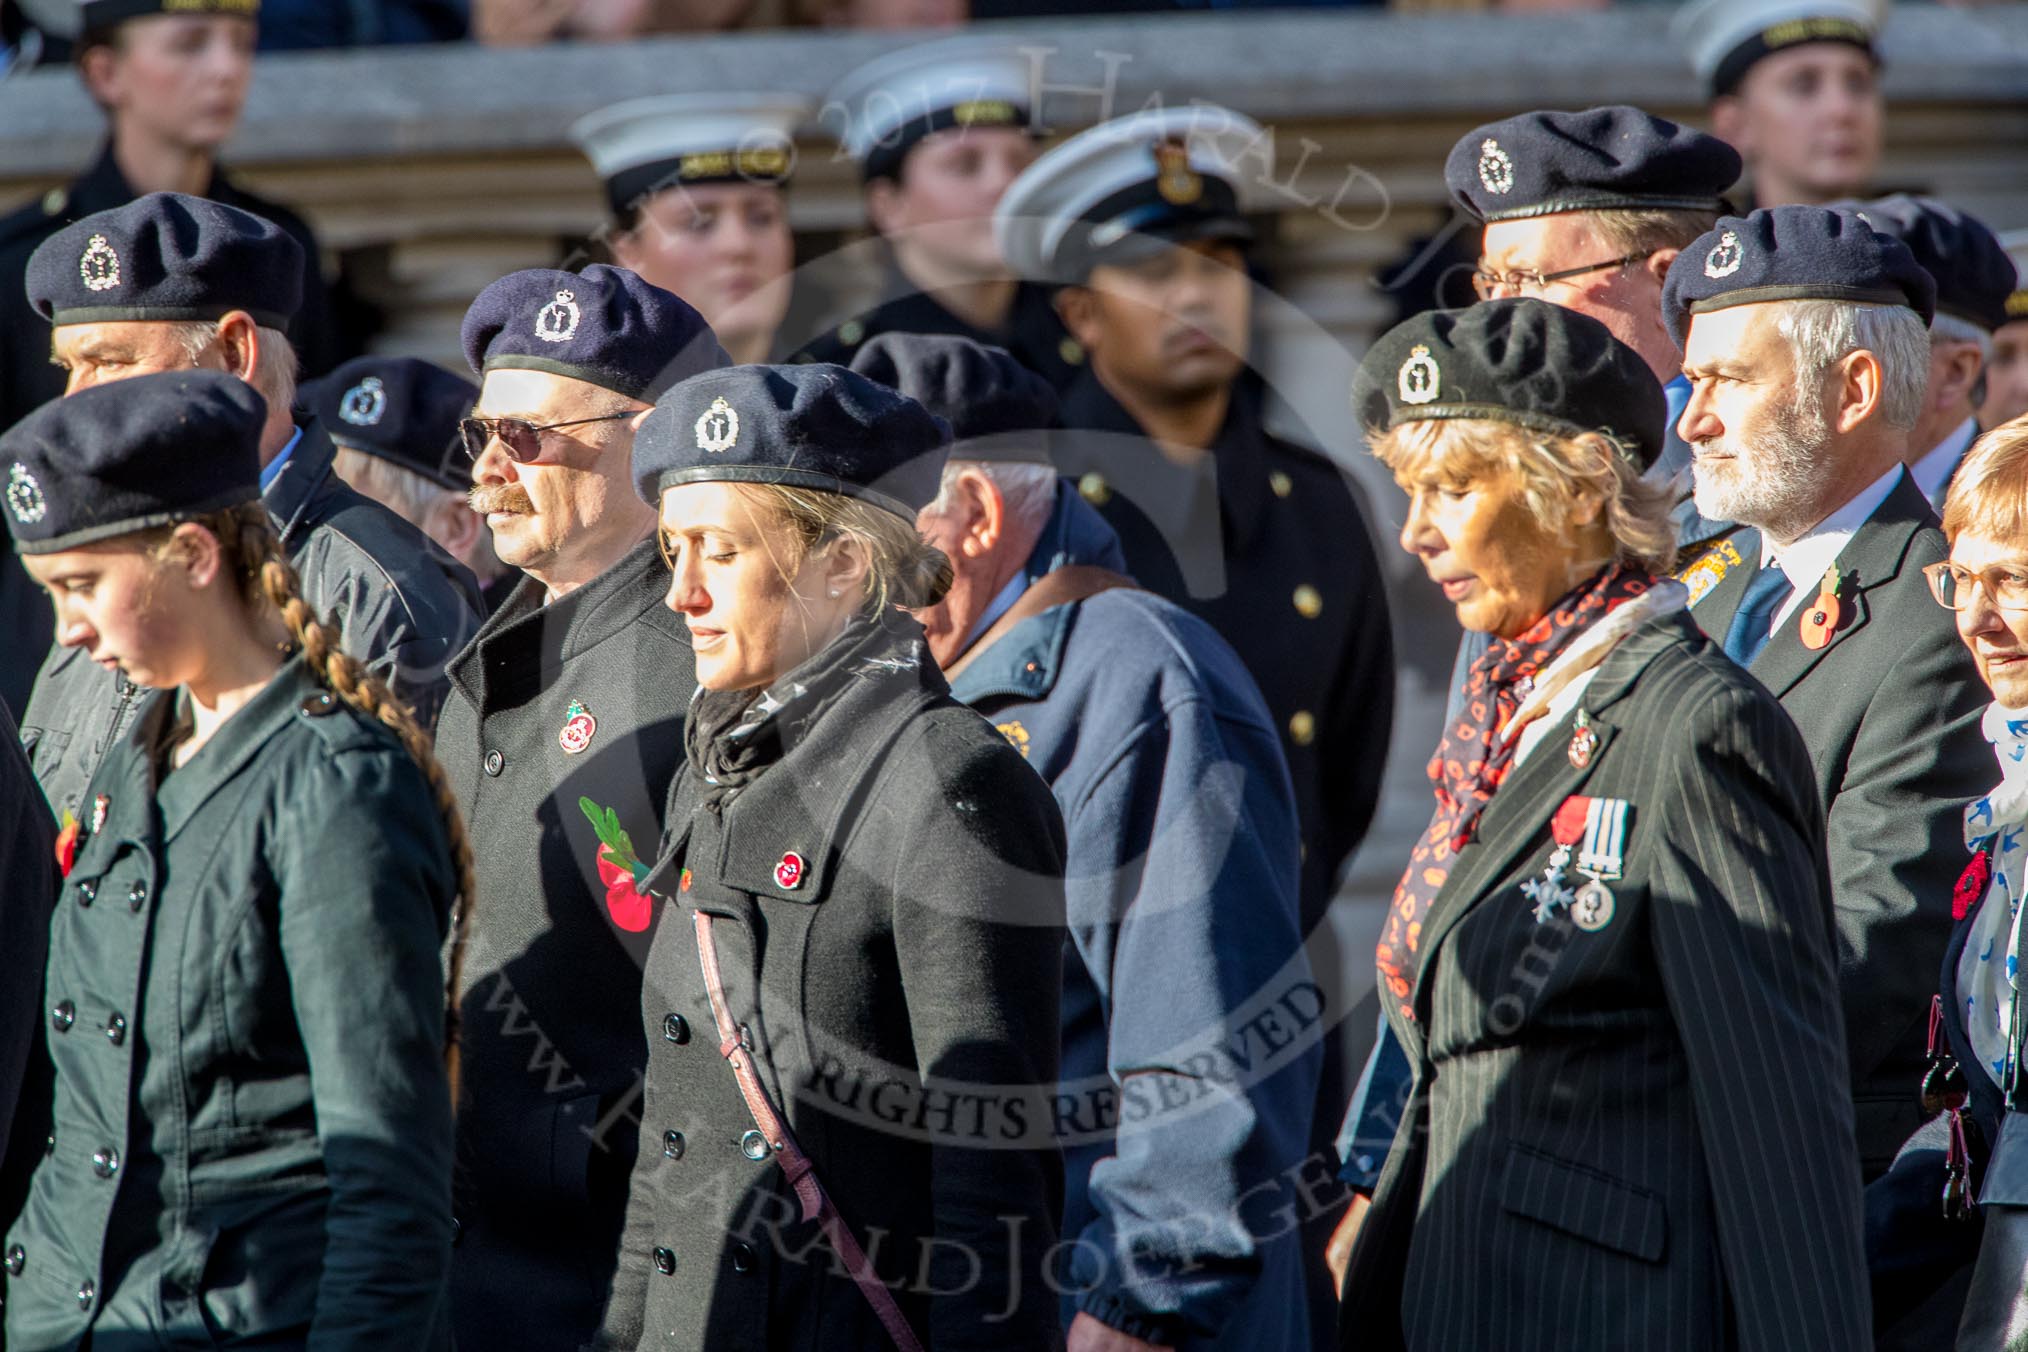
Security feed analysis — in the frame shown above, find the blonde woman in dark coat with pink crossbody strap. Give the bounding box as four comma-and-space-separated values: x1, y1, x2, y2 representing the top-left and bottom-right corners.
588, 365, 1065, 1352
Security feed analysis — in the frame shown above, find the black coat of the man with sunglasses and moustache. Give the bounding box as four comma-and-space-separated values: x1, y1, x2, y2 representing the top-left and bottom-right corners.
436, 539, 696, 1352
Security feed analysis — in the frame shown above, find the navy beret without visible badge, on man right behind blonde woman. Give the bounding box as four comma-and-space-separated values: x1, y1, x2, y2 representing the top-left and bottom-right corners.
852, 332, 1057, 464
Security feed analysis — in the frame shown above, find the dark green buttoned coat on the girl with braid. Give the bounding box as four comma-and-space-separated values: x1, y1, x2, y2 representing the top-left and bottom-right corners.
4, 661, 454, 1352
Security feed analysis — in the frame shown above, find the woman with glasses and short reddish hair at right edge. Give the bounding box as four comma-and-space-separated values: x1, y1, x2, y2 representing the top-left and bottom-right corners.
1866, 418, 2028, 1348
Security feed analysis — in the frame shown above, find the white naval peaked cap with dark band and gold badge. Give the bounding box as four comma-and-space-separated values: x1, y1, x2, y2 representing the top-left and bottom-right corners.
994, 103, 1274, 282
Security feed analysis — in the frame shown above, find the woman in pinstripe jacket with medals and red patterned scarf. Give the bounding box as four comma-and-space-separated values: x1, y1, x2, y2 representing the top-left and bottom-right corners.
1341, 300, 1870, 1352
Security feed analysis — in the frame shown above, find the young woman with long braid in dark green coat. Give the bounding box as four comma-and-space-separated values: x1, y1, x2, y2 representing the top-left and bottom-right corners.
0, 371, 470, 1352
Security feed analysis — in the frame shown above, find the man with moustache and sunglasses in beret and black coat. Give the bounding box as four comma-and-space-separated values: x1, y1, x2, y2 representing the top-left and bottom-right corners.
436, 264, 738, 1348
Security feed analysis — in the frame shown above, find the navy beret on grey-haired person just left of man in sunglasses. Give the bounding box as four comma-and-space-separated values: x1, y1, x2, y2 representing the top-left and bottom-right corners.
298, 357, 479, 493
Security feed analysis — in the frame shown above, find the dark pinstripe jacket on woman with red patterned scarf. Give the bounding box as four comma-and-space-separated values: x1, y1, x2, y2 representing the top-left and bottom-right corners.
1341, 612, 1872, 1352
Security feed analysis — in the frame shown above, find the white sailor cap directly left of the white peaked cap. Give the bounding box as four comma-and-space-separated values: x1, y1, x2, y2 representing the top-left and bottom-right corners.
819, 36, 1036, 180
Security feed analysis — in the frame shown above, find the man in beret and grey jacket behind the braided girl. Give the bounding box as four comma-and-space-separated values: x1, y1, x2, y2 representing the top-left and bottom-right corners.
20, 193, 479, 835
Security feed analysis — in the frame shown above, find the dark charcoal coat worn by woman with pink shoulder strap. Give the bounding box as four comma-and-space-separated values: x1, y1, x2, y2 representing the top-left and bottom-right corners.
602, 640, 1065, 1352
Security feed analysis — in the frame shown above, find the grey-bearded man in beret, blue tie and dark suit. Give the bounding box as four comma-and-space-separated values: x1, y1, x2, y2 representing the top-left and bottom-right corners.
1663, 207, 1991, 1180
